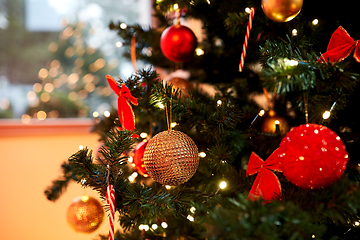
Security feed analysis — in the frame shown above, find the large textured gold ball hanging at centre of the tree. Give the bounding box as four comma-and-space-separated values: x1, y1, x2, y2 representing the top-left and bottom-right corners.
143, 130, 199, 186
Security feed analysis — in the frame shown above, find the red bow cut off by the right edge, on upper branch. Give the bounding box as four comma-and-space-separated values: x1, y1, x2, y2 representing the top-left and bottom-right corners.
318, 26, 360, 62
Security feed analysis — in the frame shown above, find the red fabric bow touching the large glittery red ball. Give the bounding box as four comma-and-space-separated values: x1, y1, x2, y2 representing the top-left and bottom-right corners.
246, 149, 281, 202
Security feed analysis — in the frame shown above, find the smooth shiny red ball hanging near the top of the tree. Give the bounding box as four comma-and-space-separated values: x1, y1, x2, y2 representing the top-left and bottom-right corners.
160, 24, 197, 62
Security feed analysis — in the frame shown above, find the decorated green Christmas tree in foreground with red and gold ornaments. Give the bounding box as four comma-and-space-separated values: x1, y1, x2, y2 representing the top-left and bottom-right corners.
45, 0, 360, 239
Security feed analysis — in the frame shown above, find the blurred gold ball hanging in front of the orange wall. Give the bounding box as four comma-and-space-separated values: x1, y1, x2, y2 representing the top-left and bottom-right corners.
67, 195, 104, 233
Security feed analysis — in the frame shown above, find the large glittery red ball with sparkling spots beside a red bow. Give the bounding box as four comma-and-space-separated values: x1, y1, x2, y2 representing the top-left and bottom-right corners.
279, 124, 349, 189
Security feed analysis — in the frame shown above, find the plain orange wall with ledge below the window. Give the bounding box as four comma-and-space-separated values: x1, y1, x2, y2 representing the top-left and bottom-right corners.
0, 120, 119, 240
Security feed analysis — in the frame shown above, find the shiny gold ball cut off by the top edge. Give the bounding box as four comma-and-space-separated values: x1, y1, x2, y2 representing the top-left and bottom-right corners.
261, 0, 303, 22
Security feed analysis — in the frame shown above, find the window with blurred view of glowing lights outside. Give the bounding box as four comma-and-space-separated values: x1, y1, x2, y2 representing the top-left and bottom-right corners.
0, 0, 151, 120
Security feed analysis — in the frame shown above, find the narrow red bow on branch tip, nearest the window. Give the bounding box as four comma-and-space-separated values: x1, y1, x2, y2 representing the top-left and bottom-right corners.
106, 75, 138, 137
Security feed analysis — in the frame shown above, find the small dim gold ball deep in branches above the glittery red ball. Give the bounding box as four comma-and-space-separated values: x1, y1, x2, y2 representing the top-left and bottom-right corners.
261, 111, 290, 134
